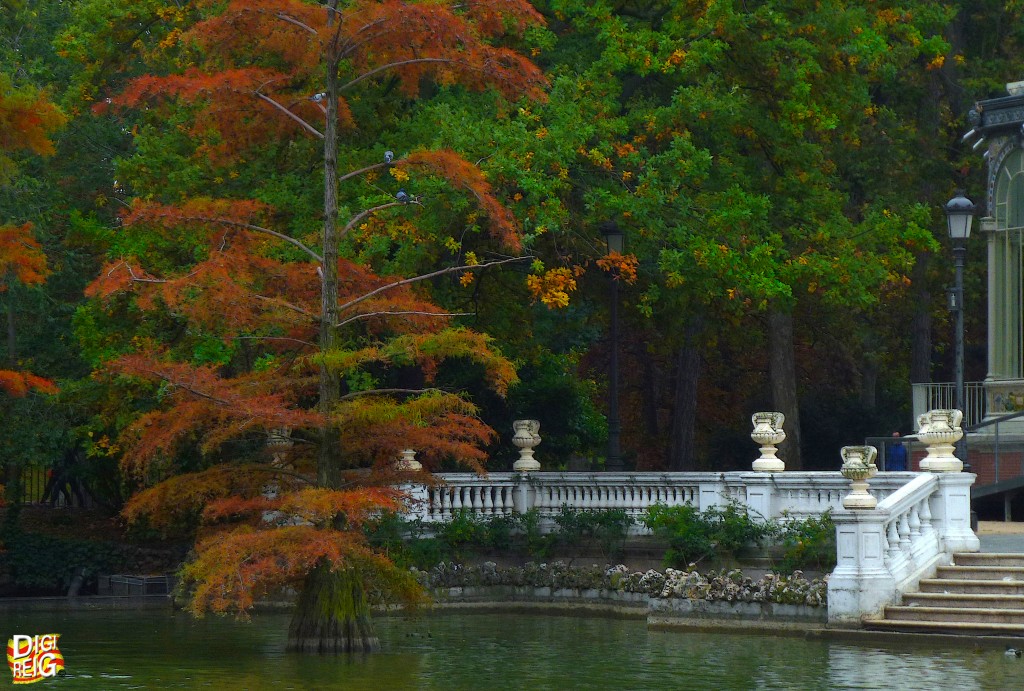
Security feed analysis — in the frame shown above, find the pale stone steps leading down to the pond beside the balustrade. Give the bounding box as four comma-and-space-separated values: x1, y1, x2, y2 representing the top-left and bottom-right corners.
863, 553, 1024, 636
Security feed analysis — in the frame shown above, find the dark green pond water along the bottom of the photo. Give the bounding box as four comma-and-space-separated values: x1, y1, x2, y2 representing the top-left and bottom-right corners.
0, 610, 1024, 691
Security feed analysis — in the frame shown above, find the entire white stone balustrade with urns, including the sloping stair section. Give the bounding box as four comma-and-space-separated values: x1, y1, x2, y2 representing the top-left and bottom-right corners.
397, 411, 980, 625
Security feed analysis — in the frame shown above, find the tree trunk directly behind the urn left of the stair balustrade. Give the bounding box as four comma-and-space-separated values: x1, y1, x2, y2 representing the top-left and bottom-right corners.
768, 307, 804, 470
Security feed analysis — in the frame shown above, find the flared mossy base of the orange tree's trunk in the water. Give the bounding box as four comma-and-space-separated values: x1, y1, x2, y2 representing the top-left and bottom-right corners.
288, 563, 381, 653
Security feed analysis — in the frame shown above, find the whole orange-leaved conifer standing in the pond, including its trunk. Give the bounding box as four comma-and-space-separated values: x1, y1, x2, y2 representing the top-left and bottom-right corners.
75, 0, 545, 652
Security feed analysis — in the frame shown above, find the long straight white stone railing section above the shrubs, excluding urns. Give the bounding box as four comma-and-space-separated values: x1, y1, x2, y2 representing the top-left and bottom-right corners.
408, 472, 916, 534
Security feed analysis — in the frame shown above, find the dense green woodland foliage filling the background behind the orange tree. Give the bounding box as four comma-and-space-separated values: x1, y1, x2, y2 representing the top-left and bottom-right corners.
0, 0, 1024, 509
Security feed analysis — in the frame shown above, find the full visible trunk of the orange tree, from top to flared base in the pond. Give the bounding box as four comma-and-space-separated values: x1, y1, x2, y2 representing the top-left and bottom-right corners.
288, 0, 380, 653
